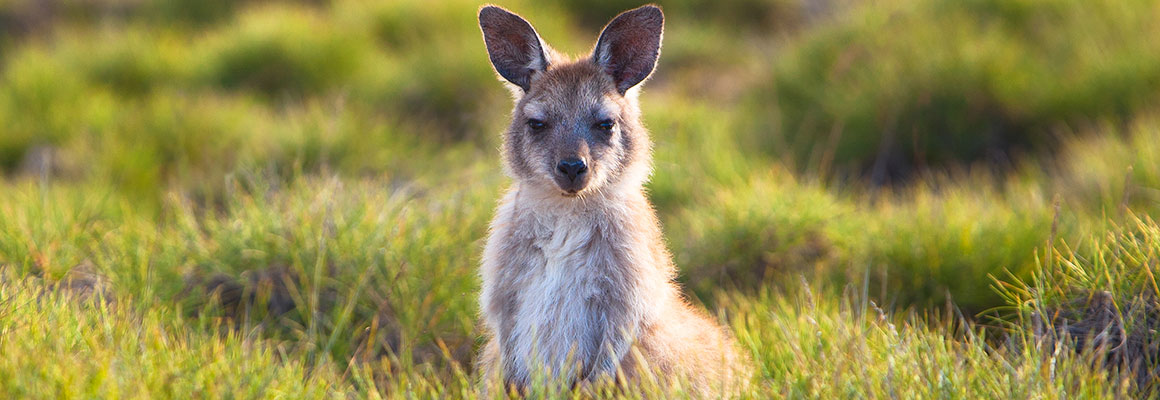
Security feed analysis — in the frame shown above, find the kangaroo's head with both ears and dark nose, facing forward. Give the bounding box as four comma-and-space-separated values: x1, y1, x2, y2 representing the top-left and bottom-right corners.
479, 6, 665, 198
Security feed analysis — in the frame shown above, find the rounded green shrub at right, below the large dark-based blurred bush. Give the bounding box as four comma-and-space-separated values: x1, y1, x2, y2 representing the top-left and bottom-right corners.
849, 179, 1057, 314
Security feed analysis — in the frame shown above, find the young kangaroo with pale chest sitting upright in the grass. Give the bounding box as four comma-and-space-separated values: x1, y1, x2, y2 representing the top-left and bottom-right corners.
478, 5, 742, 397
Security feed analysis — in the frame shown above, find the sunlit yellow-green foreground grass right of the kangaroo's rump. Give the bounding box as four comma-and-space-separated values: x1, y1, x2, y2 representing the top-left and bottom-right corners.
726, 286, 1131, 399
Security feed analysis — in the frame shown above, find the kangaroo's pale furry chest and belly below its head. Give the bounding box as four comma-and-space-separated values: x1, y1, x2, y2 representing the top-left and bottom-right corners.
480, 185, 667, 379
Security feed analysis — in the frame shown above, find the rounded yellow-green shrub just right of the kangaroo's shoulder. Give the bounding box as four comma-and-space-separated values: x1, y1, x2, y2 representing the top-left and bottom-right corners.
666, 173, 853, 298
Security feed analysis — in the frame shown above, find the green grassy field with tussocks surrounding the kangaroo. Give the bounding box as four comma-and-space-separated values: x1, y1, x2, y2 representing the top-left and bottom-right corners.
0, 0, 1160, 399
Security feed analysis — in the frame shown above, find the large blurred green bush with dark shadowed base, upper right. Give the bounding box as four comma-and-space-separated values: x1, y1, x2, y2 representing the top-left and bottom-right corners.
752, 0, 1160, 179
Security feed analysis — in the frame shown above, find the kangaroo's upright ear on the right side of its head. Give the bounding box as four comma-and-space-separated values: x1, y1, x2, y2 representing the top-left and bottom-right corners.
592, 5, 665, 94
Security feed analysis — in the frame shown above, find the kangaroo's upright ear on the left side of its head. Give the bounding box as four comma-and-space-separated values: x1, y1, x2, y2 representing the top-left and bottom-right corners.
479, 6, 548, 92
